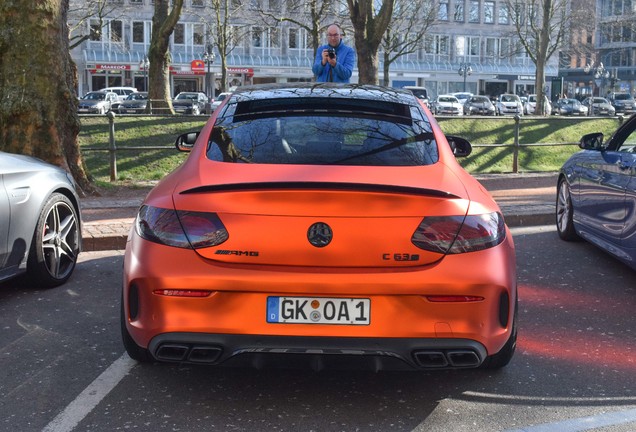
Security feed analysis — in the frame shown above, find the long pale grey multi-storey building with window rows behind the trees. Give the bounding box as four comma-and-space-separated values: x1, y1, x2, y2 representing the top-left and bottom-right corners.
69, 0, 558, 97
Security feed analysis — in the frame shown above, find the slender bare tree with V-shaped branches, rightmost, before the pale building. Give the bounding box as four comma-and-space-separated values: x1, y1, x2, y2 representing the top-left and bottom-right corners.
506, 0, 570, 113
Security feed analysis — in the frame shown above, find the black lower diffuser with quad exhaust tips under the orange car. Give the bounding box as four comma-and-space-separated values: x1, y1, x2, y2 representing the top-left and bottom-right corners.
148, 333, 486, 370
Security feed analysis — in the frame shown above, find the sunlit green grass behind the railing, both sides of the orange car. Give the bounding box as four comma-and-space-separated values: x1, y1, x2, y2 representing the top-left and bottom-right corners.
79, 116, 619, 181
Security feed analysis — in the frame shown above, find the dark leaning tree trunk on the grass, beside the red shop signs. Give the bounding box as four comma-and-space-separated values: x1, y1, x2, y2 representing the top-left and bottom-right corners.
146, 0, 183, 114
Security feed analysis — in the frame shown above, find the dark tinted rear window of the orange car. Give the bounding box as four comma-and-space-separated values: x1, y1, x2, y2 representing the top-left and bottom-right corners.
207, 98, 438, 166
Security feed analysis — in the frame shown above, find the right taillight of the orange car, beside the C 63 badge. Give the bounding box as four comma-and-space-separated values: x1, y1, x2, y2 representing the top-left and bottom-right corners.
411, 212, 506, 254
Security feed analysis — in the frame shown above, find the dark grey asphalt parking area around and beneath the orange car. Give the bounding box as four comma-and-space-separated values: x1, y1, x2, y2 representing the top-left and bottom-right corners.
0, 227, 636, 432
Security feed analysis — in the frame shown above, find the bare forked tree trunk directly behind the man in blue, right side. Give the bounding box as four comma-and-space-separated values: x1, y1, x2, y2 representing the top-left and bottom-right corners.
347, 0, 395, 84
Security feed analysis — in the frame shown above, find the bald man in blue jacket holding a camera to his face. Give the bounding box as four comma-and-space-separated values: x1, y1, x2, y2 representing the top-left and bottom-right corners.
312, 24, 355, 83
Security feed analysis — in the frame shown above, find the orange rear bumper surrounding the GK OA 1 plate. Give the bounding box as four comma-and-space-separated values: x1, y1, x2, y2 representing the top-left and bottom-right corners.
123, 233, 517, 367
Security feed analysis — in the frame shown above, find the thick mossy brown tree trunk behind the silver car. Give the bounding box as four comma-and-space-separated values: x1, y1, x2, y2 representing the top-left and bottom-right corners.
0, 0, 95, 194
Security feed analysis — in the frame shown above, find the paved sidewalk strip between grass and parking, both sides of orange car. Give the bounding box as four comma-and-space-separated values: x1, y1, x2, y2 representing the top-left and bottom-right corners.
81, 173, 557, 251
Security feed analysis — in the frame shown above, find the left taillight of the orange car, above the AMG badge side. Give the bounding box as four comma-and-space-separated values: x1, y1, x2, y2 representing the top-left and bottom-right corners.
135, 205, 229, 249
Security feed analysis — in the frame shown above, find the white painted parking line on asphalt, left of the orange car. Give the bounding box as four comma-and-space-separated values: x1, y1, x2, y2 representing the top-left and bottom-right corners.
42, 353, 137, 432
